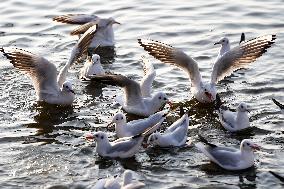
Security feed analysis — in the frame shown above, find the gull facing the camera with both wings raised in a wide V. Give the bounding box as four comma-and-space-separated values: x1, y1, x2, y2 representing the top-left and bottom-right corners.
138, 35, 276, 103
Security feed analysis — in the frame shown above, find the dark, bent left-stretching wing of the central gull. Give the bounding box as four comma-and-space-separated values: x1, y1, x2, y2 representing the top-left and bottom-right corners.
92, 74, 142, 106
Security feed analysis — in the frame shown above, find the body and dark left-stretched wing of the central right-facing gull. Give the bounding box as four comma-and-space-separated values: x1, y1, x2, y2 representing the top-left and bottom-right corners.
92, 74, 170, 117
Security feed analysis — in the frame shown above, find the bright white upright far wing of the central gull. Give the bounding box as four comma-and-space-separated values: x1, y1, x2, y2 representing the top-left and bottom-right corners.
140, 56, 156, 97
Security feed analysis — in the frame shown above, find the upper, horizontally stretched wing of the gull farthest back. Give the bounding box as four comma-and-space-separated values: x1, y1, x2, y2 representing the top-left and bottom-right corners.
53, 14, 100, 24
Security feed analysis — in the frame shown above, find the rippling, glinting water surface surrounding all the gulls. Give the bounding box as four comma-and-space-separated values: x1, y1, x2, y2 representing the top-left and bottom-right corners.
0, 0, 284, 188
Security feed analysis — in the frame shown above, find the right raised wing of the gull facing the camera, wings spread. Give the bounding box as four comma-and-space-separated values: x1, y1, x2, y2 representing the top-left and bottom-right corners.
211, 35, 276, 83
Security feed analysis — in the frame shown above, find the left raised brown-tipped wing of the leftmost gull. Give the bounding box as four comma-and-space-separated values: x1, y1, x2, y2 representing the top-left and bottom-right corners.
0, 48, 59, 95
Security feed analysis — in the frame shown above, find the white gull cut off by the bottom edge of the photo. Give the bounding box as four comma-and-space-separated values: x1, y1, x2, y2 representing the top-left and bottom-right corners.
94, 170, 145, 189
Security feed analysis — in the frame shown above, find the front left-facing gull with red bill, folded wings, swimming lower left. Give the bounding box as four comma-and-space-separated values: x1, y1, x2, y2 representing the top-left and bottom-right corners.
86, 120, 163, 158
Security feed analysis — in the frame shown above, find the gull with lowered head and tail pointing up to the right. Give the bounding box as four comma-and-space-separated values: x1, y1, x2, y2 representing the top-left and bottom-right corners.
147, 113, 189, 147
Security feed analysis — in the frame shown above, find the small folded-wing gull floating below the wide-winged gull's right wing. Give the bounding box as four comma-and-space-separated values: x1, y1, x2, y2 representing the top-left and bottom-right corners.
217, 102, 250, 132
